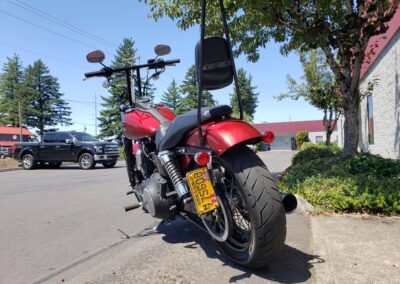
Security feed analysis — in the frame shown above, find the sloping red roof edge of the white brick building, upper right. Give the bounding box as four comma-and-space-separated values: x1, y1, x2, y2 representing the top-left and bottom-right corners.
360, 9, 400, 78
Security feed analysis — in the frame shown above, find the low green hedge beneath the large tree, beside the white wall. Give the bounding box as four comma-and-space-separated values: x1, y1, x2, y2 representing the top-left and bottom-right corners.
280, 143, 400, 214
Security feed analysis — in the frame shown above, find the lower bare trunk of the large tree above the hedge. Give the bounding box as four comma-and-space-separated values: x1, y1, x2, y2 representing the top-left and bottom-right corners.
343, 94, 360, 158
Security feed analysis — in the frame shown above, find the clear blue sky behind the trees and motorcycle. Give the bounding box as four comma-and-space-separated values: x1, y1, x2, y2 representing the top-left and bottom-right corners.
0, 0, 322, 133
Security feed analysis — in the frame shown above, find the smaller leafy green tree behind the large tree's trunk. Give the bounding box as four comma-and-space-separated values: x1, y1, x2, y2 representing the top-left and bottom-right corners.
277, 50, 343, 144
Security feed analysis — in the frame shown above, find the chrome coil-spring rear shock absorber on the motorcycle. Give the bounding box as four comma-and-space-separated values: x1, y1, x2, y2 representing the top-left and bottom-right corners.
158, 150, 188, 198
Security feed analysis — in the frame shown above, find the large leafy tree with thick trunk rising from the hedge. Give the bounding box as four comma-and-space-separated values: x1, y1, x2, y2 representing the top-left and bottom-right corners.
142, 0, 400, 157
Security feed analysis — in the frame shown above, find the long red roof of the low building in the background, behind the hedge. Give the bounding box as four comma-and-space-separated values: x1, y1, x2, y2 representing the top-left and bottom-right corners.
253, 120, 336, 134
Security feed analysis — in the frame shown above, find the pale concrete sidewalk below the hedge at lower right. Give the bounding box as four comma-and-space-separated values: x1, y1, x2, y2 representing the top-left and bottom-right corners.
311, 215, 400, 283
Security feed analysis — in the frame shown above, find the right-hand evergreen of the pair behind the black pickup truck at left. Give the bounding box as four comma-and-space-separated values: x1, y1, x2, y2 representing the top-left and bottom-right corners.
23, 59, 71, 135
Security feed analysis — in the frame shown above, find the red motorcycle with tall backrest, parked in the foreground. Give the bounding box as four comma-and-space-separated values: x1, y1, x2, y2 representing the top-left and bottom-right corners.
85, 0, 297, 268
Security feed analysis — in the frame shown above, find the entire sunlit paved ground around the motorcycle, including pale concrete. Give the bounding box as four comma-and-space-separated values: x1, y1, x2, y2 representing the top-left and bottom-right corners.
0, 151, 400, 284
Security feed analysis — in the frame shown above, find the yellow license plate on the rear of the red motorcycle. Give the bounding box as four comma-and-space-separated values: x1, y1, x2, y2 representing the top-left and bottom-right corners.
186, 168, 218, 215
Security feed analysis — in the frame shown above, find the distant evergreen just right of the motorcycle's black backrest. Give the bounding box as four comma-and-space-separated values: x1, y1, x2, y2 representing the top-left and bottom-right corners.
230, 68, 259, 121
